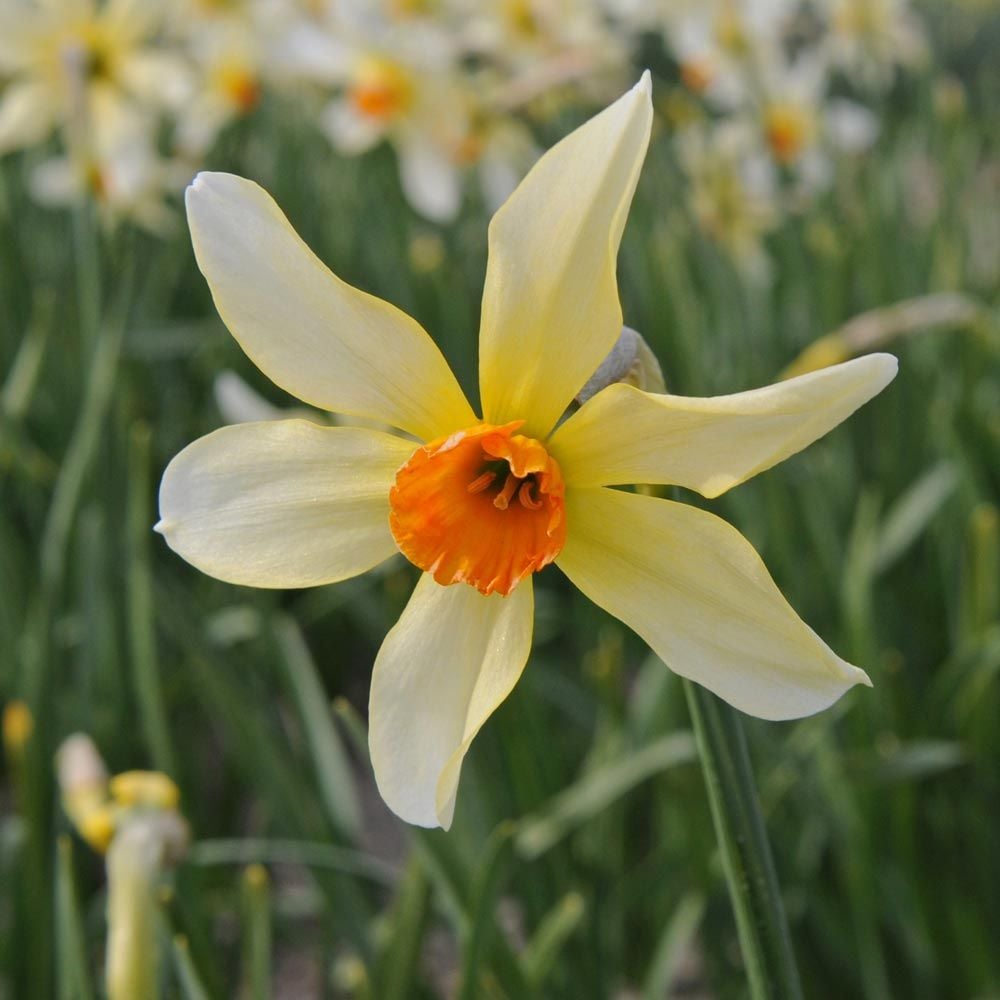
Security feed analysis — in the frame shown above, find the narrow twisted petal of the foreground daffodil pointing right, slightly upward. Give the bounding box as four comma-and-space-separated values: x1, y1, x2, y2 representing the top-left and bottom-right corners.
549, 354, 897, 497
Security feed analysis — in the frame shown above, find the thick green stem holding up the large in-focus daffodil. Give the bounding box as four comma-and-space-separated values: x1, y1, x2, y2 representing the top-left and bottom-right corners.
684, 681, 802, 1000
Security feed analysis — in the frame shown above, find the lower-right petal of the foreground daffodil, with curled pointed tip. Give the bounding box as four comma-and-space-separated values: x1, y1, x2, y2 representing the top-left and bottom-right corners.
556, 488, 871, 719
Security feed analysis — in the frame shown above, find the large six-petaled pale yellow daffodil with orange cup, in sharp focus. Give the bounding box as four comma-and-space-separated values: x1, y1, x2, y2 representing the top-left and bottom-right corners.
158, 76, 896, 827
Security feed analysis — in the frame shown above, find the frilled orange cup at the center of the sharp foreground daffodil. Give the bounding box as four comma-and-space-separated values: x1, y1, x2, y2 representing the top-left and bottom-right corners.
389, 420, 566, 596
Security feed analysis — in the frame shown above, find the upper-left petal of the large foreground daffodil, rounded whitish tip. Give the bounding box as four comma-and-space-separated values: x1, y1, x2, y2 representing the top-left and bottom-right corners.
187, 173, 475, 440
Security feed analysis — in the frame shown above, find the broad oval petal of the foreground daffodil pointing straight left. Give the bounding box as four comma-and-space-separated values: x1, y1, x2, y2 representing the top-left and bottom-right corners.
156, 420, 413, 587
